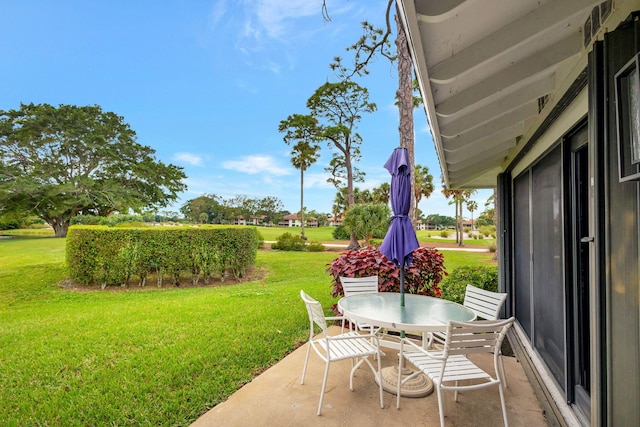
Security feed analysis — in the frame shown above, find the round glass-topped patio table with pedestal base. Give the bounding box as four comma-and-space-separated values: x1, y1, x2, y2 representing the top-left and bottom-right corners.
338, 292, 476, 397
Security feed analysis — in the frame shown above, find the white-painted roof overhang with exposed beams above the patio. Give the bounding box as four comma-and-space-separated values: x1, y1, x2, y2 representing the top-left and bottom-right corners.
398, 0, 638, 189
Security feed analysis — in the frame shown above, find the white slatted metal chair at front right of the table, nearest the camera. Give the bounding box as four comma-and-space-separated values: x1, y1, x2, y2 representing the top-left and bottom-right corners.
396, 317, 515, 427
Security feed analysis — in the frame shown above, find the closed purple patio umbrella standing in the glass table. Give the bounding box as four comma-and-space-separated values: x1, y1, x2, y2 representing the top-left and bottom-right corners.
380, 147, 420, 307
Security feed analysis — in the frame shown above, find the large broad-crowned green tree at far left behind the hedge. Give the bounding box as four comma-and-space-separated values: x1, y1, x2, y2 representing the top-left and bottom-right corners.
0, 104, 186, 237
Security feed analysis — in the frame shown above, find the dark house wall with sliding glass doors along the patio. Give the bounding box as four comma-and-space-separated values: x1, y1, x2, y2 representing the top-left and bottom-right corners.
499, 16, 640, 426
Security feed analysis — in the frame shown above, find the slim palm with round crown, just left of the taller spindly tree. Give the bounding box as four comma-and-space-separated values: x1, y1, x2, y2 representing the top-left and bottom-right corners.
278, 114, 320, 240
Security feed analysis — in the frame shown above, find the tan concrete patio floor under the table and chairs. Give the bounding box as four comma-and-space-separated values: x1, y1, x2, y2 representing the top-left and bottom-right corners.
192, 327, 548, 427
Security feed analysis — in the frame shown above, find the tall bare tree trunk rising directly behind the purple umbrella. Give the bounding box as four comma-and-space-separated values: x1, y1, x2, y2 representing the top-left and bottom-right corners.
395, 9, 416, 227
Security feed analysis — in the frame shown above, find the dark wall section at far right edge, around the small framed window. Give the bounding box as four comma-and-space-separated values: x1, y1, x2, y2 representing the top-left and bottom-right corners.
602, 22, 640, 426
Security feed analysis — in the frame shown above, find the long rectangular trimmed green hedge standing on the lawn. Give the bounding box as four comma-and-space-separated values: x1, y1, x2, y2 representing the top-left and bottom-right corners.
66, 226, 259, 288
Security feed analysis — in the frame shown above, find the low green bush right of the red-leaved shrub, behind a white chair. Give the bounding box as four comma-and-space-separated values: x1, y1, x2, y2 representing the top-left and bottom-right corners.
442, 265, 498, 304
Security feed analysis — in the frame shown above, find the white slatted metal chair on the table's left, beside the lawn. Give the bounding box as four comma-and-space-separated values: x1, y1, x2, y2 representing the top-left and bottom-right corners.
300, 290, 384, 415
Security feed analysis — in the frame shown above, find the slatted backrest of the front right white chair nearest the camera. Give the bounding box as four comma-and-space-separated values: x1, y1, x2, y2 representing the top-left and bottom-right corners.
444, 317, 515, 357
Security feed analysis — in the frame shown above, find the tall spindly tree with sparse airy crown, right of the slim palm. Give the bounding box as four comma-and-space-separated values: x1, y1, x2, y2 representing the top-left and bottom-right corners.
307, 81, 377, 249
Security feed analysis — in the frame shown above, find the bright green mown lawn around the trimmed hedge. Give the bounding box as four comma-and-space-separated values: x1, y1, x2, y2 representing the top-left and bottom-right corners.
0, 239, 490, 426
